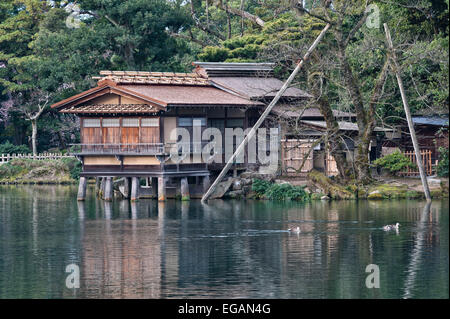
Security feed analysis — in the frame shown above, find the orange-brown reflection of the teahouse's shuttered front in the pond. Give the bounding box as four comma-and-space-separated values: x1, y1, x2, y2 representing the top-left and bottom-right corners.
80, 201, 167, 298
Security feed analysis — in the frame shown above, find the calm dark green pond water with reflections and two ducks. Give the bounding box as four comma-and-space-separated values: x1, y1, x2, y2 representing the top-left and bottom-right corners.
0, 186, 449, 298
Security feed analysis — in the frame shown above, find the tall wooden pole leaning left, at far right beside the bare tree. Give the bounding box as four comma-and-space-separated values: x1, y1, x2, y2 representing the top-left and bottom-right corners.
383, 23, 431, 202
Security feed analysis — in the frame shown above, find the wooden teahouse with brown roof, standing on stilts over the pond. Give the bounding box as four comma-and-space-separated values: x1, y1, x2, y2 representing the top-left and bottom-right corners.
52, 63, 309, 200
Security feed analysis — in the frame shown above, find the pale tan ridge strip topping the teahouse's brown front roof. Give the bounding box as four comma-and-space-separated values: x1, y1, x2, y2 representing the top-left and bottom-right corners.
93, 71, 209, 86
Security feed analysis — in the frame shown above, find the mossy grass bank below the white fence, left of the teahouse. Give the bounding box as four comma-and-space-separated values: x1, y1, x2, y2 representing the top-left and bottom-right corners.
0, 158, 81, 184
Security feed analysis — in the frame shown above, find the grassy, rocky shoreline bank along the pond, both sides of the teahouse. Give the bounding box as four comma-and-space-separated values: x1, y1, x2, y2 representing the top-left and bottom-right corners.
0, 159, 449, 201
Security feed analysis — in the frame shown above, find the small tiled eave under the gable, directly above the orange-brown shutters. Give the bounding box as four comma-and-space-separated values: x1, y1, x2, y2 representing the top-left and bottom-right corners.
61, 104, 159, 114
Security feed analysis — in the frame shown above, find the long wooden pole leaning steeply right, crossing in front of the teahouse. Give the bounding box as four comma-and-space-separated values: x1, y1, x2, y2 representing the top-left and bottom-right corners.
202, 24, 330, 203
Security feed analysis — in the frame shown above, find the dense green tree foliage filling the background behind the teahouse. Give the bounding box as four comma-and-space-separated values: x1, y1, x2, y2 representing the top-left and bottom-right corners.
0, 0, 449, 182
